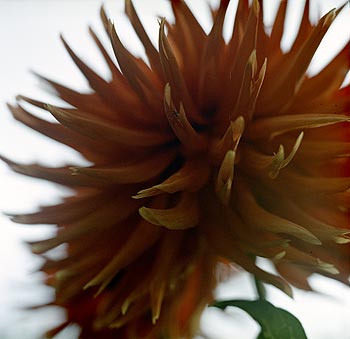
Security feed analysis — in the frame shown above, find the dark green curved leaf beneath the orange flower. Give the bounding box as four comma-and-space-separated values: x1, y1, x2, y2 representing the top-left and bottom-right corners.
211, 300, 307, 339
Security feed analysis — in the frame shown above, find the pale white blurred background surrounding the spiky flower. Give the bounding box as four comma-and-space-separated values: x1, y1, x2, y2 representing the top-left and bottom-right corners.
0, 0, 350, 339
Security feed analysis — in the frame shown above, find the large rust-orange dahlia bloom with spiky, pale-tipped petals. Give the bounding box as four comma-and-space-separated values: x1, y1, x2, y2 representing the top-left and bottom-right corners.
4, 0, 350, 339
